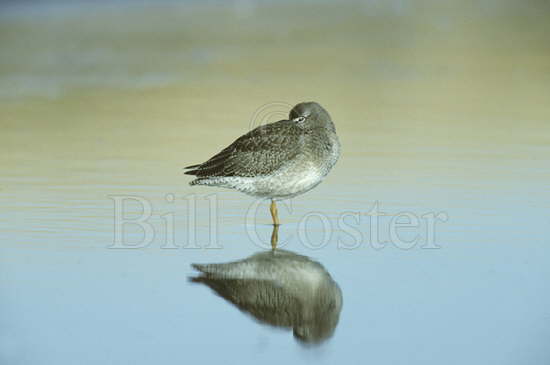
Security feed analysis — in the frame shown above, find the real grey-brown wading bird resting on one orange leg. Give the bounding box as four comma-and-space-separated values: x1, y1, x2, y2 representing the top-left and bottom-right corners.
185, 101, 341, 226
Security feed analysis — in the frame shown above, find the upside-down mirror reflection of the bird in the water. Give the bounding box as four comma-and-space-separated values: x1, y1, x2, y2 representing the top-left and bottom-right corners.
191, 226, 342, 344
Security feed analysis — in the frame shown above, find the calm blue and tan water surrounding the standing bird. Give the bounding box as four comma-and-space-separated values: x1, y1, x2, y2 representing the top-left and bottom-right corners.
0, 1, 550, 364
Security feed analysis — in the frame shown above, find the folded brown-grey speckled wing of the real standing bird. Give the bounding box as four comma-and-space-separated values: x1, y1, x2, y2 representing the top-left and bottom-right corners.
186, 120, 305, 178
